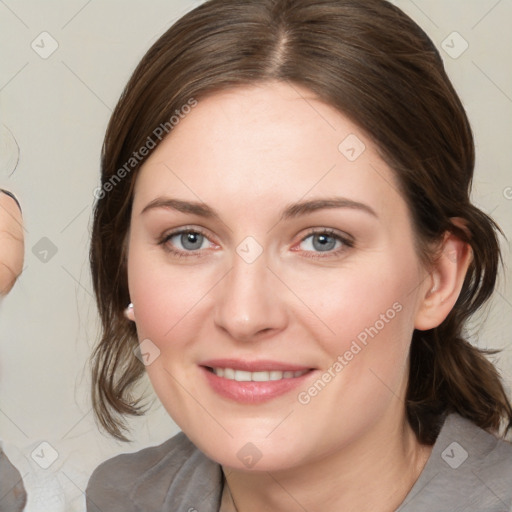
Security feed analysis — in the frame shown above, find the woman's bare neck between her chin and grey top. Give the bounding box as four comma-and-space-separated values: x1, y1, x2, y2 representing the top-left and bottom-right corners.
223, 415, 432, 512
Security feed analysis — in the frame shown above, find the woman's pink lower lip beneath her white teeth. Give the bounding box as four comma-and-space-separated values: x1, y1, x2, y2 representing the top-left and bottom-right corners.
200, 366, 313, 404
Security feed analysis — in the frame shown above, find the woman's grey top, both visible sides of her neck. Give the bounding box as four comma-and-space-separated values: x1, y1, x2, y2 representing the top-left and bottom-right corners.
86, 414, 512, 512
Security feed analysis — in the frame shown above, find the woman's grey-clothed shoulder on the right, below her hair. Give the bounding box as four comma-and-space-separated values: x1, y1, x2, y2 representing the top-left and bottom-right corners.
399, 414, 512, 512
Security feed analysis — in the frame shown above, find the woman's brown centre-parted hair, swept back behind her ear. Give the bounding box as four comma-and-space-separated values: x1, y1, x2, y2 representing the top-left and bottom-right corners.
90, 0, 512, 444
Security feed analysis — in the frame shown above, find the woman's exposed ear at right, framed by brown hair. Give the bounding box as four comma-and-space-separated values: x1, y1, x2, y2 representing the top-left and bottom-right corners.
414, 222, 473, 331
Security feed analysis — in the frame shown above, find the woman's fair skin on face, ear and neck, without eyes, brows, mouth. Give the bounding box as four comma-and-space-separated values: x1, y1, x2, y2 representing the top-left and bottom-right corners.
127, 82, 470, 512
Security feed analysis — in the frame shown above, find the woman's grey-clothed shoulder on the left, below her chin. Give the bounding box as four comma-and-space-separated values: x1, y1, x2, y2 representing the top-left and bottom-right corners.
86, 432, 222, 512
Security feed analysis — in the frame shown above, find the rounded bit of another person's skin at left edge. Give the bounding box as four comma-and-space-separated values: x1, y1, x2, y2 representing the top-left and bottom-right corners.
0, 192, 25, 297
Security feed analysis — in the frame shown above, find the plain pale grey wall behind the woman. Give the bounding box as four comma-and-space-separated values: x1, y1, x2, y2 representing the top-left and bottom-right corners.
0, 0, 512, 512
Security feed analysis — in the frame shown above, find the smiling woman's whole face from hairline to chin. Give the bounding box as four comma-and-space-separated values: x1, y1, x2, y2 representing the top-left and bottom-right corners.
128, 82, 428, 470
